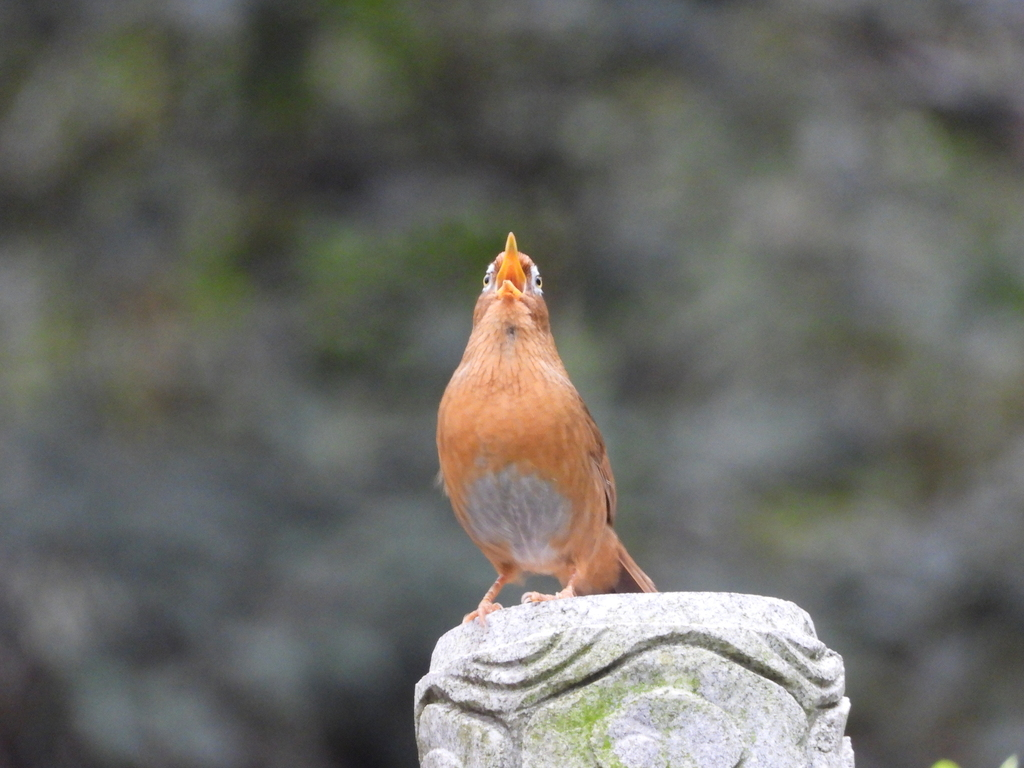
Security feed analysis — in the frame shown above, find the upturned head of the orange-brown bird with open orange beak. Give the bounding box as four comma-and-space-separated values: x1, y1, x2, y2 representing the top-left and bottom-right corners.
473, 232, 549, 331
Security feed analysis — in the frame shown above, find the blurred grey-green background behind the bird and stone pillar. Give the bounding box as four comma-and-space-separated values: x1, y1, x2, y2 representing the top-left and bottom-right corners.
0, 0, 1024, 768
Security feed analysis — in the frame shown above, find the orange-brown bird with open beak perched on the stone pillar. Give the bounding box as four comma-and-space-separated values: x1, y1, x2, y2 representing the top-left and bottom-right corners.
437, 232, 656, 624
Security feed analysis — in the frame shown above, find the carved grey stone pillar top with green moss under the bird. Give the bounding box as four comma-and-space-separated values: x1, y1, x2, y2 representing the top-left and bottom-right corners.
416, 592, 853, 768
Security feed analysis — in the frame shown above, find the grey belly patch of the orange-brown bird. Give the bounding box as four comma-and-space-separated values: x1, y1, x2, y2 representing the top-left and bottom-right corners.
466, 467, 571, 573
